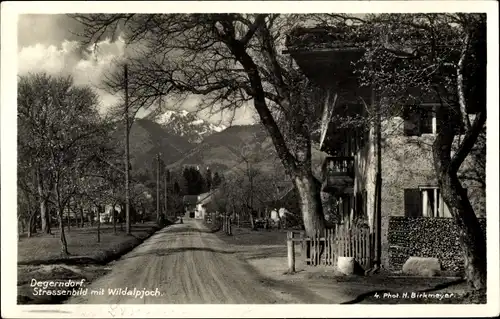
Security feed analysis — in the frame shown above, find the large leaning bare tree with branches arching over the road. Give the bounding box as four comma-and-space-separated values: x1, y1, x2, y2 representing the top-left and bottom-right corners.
72, 14, 325, 238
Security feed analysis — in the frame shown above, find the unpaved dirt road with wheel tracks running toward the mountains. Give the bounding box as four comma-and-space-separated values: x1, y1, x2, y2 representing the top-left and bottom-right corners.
67, 219, 326, 304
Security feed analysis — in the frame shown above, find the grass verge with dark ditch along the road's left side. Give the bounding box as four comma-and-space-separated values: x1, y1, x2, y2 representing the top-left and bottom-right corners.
17, 222, 166, 304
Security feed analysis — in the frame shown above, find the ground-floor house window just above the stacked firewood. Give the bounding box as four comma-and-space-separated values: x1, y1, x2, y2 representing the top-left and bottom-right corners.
404, 187, 451, 217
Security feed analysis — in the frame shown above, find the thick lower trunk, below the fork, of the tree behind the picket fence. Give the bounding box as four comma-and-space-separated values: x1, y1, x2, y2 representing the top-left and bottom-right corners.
294, 173, 325, 236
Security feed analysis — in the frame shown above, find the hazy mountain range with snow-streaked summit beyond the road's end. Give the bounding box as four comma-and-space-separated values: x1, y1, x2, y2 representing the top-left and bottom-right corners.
116, 111, 324, 185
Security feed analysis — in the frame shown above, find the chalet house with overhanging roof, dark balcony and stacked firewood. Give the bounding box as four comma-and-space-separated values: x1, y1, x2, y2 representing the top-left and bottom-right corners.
284, 27, 485, 271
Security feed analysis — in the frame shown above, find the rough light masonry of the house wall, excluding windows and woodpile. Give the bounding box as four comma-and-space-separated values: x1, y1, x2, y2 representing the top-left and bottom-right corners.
316, 87, 485, 268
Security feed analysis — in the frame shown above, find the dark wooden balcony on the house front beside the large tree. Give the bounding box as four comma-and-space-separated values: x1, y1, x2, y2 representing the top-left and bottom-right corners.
322, 156, 354, 194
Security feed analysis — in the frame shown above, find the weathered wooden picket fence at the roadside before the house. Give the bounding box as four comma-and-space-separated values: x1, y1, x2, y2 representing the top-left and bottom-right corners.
287, 225, 373, 271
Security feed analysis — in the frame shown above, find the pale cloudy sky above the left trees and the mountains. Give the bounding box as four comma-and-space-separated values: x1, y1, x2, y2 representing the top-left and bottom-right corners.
17, 14, 255, 125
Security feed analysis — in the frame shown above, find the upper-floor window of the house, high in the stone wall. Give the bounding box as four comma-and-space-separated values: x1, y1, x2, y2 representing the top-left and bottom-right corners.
403, 104, 437, 136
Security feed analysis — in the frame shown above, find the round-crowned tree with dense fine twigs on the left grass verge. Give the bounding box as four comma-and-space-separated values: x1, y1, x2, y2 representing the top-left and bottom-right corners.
18, 74, 111, 255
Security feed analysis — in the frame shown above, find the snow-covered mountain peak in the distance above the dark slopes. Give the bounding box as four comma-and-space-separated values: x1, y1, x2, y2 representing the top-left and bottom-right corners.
156, 110, 226, 143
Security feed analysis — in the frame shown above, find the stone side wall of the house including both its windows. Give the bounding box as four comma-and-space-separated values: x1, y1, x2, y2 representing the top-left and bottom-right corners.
382, 112, 485, 266
